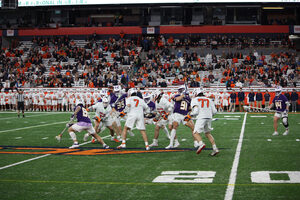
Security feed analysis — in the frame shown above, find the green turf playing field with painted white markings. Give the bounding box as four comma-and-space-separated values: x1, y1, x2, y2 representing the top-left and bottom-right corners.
0, 112, 300, 200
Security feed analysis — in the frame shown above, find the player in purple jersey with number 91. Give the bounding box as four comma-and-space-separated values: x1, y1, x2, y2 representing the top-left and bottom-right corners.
166, 85, 194, 149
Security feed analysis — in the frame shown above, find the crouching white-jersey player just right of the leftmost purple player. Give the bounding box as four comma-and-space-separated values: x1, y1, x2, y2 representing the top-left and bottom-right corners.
84, 97, 121, 142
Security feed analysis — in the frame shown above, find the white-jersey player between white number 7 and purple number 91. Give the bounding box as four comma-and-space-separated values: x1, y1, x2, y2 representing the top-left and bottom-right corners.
149, 91, 174, 147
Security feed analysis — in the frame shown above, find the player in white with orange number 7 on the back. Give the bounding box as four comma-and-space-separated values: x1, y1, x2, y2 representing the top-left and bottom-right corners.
118, 88, 150, 150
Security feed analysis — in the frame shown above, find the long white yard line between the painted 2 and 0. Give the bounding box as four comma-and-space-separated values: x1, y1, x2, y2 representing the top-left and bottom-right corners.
224, 112, 247, 200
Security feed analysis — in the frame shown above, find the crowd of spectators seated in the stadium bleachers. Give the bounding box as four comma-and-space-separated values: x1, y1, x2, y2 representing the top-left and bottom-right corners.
0, 35, 300, 90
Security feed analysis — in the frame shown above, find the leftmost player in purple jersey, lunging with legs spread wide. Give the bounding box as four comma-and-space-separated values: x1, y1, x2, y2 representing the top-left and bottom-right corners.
67, 100, 109, 149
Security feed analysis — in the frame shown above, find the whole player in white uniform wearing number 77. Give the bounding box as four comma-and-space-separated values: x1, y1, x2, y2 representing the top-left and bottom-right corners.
190, 88, 219, 156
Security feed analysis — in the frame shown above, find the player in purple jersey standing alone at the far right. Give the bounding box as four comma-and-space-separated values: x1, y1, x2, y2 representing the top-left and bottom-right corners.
269, 87, 290, 136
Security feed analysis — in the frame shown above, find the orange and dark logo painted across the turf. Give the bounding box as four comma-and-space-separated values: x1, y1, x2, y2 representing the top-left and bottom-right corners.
0, 146, 192, 156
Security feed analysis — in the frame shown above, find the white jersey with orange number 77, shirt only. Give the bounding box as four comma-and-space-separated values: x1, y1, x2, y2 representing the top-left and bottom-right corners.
191, 97, 217, 119
